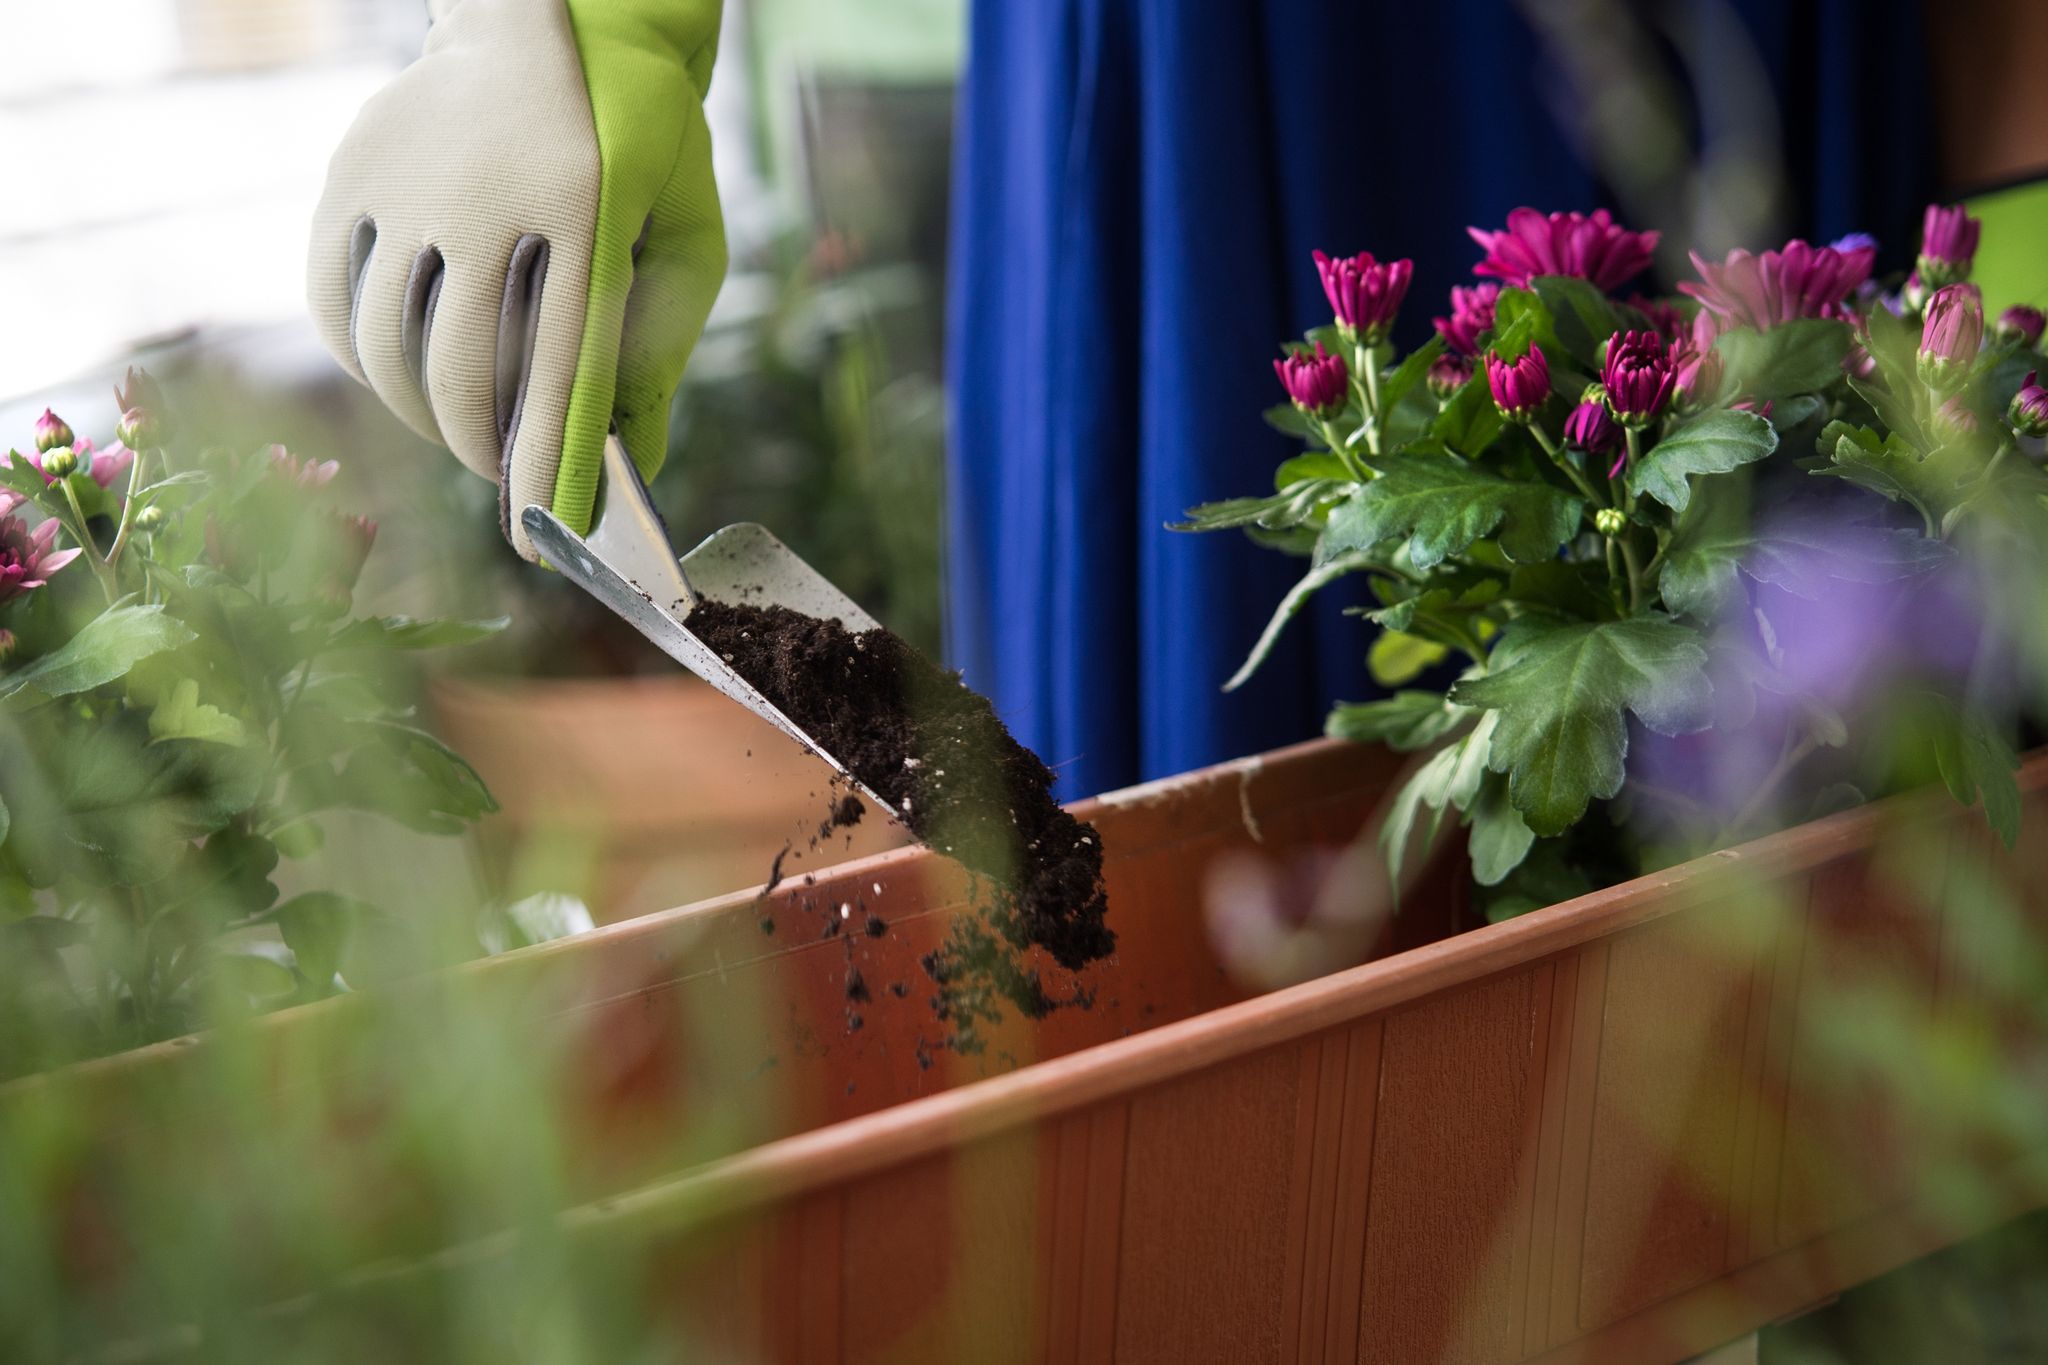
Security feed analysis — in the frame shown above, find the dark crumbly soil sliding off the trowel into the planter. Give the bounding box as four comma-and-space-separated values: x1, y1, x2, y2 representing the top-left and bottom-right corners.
688, 600, 1116, 1052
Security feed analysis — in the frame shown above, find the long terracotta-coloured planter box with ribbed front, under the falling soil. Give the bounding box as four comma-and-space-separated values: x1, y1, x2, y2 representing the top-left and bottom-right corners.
10, 743, 2048, 1365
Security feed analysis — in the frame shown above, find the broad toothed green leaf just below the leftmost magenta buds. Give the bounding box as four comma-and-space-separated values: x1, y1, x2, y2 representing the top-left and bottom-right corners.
1317, 452, 1585, 569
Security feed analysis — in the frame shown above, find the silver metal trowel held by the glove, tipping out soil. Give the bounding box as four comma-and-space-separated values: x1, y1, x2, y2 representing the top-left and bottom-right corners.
520, 432, 901, 819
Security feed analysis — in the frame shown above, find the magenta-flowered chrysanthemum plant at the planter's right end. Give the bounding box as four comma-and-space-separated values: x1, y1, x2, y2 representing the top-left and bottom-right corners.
1180, 207, 2048, 917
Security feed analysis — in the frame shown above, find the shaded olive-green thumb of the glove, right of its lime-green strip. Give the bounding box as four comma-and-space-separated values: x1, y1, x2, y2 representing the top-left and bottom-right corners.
612, 104, 727, 491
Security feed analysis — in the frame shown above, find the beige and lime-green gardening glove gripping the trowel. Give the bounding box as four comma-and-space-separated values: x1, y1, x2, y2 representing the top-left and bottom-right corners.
307, 0, 725, 559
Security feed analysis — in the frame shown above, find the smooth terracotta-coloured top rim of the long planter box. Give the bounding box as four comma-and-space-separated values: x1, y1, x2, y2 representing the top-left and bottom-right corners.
457, 739, 2048, 1250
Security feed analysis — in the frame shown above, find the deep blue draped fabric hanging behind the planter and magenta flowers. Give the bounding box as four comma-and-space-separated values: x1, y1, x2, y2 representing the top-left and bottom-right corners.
946, 0, 1925, 798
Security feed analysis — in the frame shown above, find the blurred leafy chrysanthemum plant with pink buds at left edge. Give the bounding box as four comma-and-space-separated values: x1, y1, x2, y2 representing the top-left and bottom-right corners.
0, 372, 502, 1076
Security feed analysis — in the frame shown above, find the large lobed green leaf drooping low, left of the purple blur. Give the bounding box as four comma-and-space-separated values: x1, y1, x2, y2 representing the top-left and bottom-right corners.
1450, 616, 1712, 835
